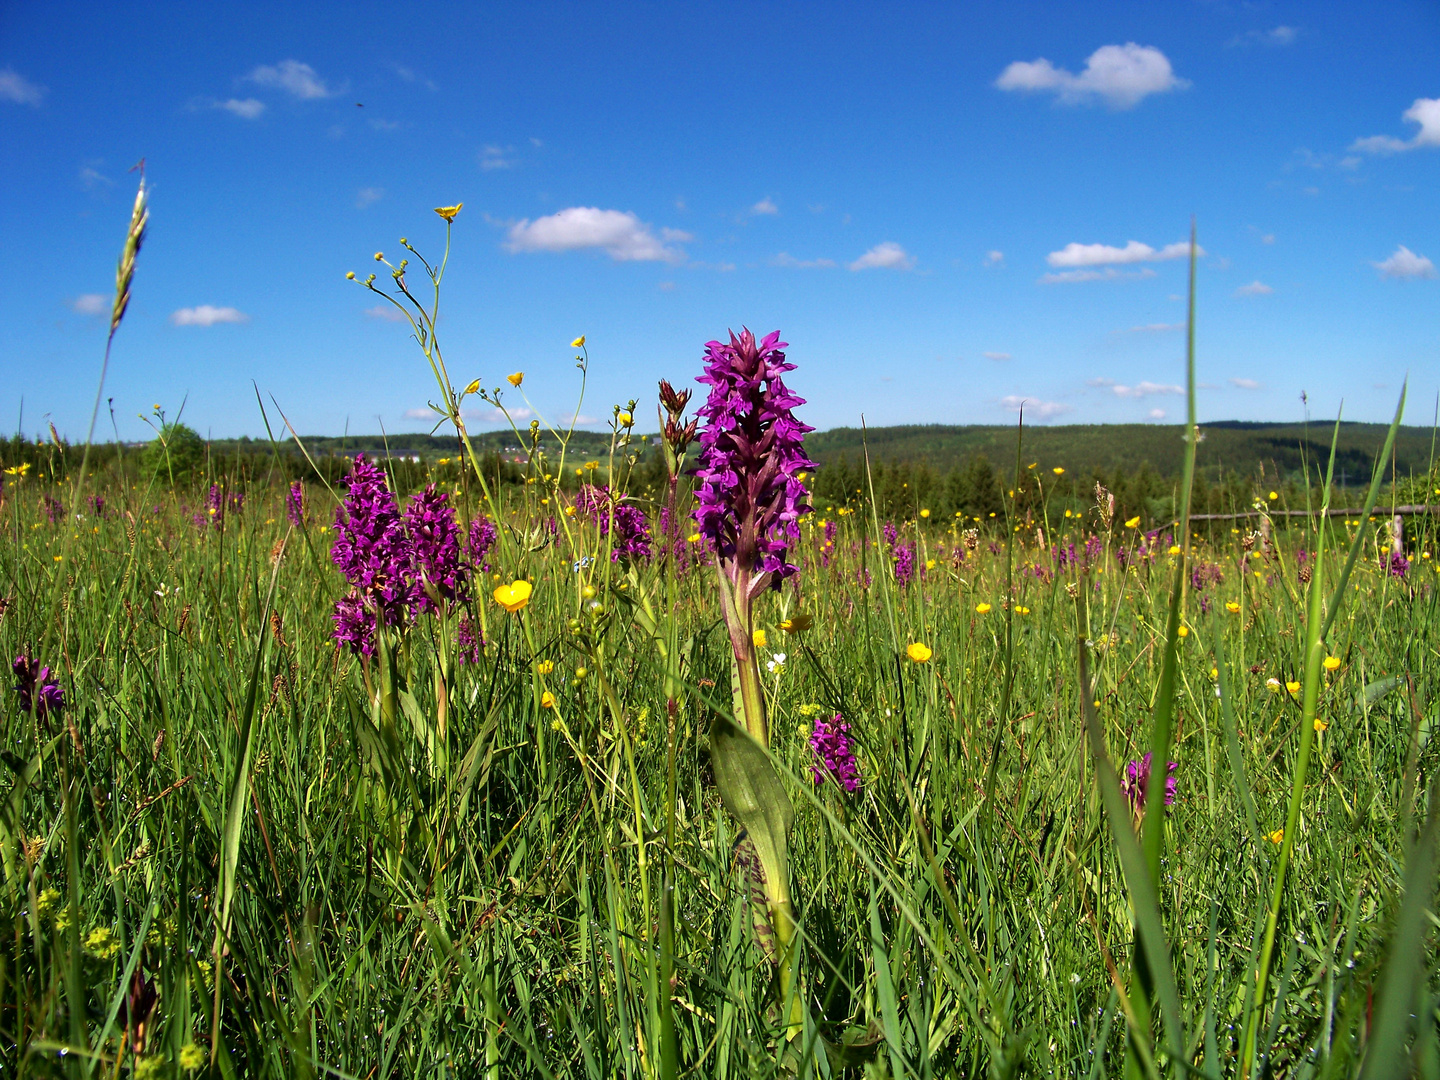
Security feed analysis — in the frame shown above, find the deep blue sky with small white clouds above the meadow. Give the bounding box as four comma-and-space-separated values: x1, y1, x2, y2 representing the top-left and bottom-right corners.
0, 0, 1440, 438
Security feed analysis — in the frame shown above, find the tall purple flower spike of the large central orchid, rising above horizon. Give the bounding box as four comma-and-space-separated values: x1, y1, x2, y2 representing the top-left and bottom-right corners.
694, 330, 815, 588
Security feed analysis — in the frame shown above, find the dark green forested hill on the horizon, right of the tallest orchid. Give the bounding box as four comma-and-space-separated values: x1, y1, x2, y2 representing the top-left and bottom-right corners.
805, 420, 1433, 485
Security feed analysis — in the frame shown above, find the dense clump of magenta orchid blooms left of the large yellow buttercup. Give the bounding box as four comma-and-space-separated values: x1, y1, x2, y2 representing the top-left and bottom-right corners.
330, 454, 478, 657
